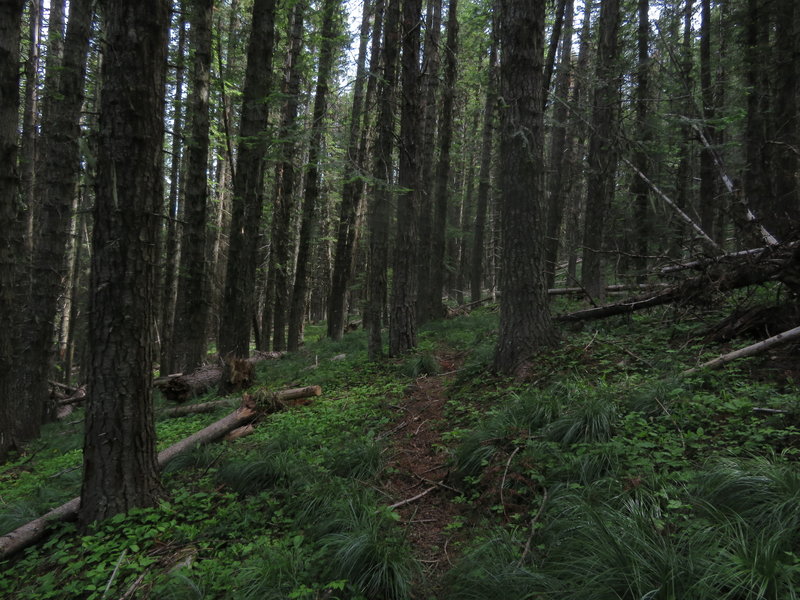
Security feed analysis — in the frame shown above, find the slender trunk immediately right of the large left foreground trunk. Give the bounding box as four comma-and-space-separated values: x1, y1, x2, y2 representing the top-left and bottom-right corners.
158, 0, 186, 375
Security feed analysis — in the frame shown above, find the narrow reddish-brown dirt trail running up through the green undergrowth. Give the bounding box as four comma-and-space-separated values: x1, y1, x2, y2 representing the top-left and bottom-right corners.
384, 354, 461, 592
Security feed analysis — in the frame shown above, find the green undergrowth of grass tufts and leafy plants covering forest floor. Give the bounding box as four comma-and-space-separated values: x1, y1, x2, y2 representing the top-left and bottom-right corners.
0, 307, 800, 600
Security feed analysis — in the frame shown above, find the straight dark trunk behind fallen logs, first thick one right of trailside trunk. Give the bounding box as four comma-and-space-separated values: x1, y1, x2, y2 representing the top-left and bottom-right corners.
581, 0, 620, 298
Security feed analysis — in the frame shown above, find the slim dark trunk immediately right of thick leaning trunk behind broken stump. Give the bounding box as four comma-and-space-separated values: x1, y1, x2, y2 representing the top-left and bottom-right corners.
262, 0, 306, 350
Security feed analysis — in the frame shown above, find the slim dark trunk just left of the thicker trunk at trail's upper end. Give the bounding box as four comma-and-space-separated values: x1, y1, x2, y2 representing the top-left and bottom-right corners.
364, 0, 400, 360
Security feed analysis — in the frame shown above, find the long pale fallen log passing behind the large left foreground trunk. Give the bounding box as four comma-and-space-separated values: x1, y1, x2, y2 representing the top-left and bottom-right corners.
0, 386, 322, 560
